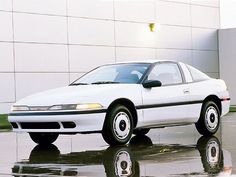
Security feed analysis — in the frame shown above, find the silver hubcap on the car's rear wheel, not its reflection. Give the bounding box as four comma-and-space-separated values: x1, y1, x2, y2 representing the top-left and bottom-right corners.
205, 106, 219, 131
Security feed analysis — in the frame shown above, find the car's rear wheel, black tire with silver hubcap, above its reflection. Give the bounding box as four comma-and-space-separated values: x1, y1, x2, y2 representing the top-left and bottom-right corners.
195, 101, 220, 136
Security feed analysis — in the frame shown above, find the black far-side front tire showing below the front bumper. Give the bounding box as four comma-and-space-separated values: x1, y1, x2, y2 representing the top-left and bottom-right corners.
29, 133, 58, 146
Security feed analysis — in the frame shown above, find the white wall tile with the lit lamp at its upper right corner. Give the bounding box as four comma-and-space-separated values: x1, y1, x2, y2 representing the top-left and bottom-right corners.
115, 22, 156, 47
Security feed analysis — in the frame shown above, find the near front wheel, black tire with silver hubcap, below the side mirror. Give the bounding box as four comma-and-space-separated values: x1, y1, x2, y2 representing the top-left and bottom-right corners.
102, 104, 133, 146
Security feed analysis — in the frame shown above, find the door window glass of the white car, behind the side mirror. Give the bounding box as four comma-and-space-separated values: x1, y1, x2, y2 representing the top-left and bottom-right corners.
148, 63, 183, 85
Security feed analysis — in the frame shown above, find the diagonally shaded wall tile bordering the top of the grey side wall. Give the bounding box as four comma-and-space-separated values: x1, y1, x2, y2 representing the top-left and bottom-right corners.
192, 28, 218, 50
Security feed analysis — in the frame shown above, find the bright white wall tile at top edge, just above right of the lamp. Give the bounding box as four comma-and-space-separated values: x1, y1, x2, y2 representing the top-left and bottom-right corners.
156, 0, 191, 26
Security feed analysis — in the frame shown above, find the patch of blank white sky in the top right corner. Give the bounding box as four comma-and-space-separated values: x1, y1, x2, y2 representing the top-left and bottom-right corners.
220, 0, 236, 29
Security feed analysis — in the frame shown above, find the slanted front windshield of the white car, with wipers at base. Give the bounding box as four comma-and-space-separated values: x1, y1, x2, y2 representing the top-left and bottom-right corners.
70, 63, 150, 85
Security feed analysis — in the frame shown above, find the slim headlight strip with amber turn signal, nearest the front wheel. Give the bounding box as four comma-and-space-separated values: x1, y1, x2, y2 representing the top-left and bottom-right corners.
49, 103, 102, 111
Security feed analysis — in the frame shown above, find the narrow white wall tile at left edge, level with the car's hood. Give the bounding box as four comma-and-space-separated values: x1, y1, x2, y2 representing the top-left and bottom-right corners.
0, 73, 15, 102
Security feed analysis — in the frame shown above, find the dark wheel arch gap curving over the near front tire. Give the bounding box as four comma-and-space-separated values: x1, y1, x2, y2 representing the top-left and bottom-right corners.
107, 98, 138, 128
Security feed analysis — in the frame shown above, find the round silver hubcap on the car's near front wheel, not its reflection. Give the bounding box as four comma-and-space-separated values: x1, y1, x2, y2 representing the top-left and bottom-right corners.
113, 112, 131, 140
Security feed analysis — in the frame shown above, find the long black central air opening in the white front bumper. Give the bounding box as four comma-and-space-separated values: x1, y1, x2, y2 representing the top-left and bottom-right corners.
20, 122, 60, 129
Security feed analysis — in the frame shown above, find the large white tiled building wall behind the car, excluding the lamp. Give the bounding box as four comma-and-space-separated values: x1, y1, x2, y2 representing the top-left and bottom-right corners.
0, 0, 219, 113
